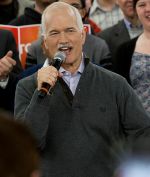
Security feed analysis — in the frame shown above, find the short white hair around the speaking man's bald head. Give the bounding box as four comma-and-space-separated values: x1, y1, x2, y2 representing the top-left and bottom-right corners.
41, 2, 84, 35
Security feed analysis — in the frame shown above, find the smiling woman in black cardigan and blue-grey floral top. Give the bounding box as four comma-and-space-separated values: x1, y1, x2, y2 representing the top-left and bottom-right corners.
115, 0, 150, 115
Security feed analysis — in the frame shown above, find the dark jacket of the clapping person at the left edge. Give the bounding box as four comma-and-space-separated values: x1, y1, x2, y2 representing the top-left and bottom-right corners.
0, 30, 22, 111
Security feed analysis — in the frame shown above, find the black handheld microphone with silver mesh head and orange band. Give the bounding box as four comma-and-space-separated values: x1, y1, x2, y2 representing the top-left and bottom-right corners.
39, 51, 66, 98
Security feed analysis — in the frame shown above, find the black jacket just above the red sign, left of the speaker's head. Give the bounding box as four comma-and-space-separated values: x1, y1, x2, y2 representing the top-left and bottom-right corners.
9, 7, 41, 26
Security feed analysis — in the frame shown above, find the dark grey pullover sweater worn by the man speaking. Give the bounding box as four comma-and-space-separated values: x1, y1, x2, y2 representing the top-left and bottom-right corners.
15, 57, 150, 177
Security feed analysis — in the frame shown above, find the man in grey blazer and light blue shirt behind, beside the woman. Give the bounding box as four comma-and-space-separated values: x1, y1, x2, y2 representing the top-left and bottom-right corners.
98, 0, 143, 68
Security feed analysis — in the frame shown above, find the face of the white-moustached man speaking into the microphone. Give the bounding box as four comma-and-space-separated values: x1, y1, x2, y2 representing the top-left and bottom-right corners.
45, 9, 85, 66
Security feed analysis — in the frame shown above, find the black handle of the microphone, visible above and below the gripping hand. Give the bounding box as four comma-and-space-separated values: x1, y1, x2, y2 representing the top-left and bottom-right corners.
38, 59, 62, 98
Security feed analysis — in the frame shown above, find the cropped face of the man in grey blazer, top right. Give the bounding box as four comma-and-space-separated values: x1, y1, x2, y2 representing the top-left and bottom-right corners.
117, 0, 136, 18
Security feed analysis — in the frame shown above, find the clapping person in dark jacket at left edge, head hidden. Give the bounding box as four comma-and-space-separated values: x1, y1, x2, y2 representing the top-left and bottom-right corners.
0, 29, 23, 112
